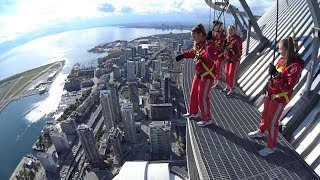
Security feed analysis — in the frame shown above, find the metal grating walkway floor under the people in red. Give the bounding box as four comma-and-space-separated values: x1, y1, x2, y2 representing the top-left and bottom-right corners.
183, 60, 319, 180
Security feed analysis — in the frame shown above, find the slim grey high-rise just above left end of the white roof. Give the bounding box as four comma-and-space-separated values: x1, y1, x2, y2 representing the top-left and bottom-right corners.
109, 128, 122, 159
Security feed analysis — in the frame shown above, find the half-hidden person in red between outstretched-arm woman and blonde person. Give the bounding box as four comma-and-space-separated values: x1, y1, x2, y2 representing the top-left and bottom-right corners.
212, 20, 226, 88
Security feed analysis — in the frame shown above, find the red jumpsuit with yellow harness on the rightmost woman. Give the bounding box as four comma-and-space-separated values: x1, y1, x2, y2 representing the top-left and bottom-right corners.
259, 54, 303, 148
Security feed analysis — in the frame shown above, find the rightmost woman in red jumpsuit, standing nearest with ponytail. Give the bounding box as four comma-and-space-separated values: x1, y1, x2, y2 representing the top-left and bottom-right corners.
248, 37, 303, 156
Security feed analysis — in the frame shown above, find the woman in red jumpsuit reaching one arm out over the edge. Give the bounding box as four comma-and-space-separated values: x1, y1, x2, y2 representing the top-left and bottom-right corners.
176, 24, 214, 126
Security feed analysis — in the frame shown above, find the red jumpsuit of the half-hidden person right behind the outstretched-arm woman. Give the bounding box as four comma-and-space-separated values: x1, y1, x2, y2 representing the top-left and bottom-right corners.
212, 32, 226, 80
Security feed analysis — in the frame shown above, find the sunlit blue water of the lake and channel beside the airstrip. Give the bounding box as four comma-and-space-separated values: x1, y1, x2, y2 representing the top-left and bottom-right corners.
0, 27, 187, 180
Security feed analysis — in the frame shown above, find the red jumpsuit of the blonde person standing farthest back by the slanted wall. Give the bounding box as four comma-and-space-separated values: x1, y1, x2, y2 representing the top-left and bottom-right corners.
225, 34, 242, 90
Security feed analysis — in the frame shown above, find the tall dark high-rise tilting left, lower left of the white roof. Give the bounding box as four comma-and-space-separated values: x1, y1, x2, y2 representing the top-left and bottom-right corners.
77, 124, 103, 166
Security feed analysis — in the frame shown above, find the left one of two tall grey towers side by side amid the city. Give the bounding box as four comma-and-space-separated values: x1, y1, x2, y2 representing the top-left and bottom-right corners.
100, 90, 115, 131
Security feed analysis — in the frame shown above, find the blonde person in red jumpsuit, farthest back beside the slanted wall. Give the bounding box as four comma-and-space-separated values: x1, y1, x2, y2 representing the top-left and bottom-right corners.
222, 24, 242, 96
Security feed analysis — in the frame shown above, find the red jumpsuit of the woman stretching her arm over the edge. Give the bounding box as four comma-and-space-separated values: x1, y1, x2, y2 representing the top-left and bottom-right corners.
183, 41, 214, 121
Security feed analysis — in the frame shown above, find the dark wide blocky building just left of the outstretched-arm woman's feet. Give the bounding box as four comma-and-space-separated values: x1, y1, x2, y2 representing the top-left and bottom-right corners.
150, 103, 173, 121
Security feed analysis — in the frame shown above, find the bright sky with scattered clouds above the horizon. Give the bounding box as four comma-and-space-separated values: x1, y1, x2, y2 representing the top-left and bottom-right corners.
0, 0, 276, 44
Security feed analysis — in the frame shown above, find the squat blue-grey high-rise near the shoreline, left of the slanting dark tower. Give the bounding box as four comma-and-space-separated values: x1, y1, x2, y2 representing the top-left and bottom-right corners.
49, 132, 70, 153
